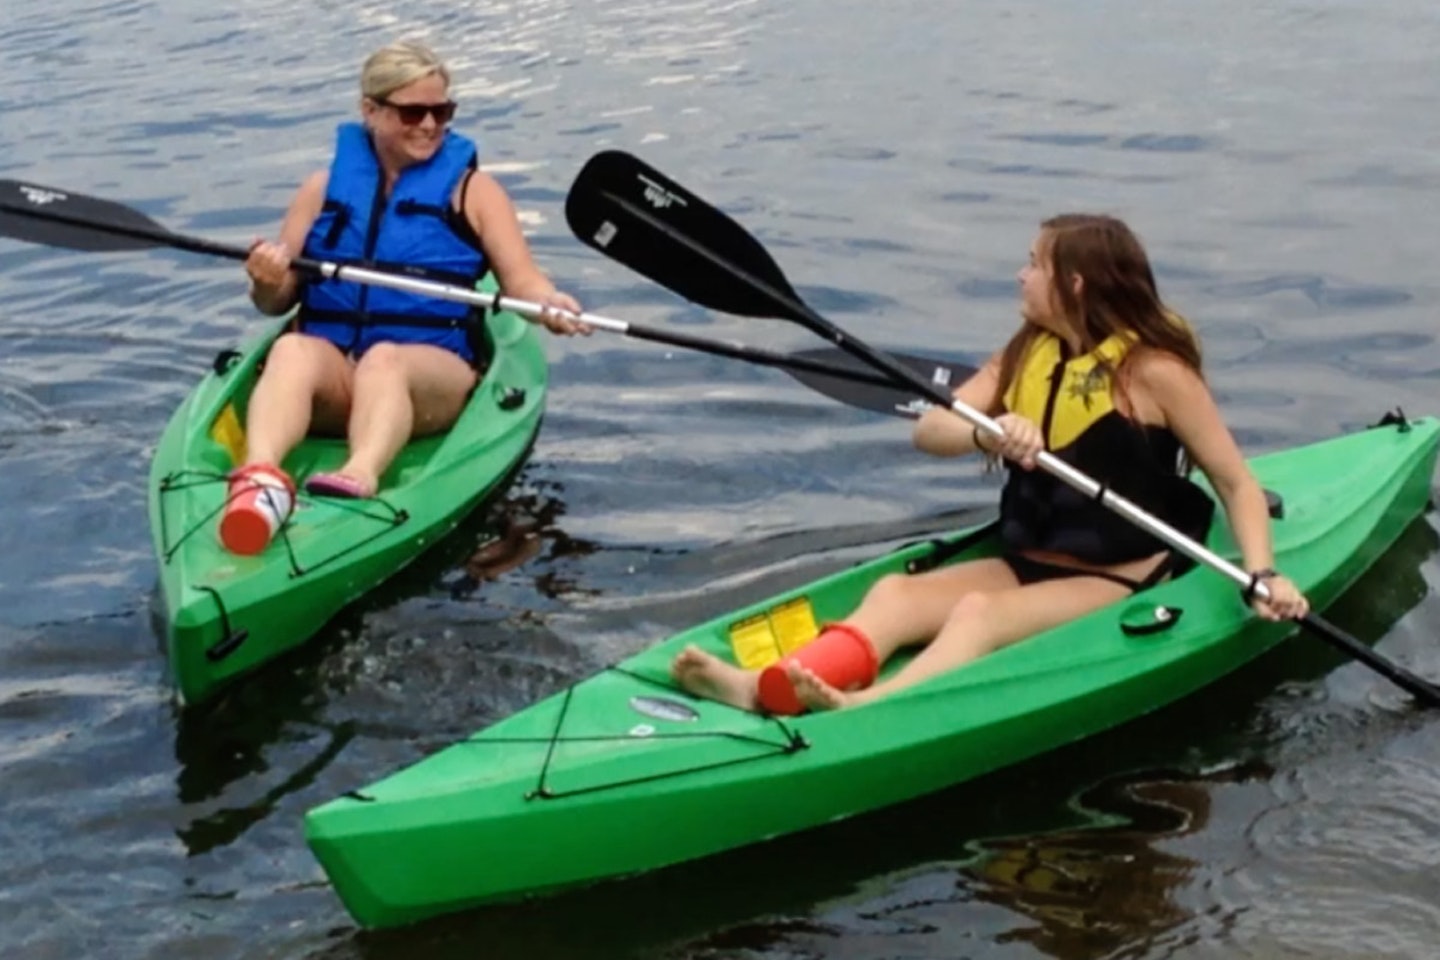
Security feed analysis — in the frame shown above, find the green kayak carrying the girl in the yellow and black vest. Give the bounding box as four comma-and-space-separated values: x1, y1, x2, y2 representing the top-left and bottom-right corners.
305, 419, 1440, 927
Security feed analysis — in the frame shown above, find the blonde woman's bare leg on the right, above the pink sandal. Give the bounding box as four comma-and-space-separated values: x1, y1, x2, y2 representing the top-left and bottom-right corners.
331, 344, 477, 492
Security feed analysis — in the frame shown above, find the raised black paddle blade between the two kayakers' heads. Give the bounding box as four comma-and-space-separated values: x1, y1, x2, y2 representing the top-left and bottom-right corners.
564, 150, 804, 320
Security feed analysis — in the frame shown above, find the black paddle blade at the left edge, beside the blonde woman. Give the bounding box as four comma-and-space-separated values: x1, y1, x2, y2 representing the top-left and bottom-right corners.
0, 180, 170, 252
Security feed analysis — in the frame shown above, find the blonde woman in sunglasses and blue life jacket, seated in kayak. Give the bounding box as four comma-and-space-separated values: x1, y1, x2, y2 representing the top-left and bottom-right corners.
220, 42, 589, 552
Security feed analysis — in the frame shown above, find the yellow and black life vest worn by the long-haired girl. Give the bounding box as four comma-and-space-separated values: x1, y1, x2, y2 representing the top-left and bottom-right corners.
1001, 332, 1214, 564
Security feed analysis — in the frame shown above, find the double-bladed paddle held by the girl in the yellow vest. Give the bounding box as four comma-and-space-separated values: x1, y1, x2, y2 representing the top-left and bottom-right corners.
564, 150, 1440, 707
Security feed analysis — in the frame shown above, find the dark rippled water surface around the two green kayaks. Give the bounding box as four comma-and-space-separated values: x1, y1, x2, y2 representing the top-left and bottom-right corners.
0, 0, 1440, 960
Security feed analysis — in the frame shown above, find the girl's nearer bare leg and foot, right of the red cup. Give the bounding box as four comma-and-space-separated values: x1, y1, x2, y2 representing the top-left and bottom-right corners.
791, 577, 1130, 710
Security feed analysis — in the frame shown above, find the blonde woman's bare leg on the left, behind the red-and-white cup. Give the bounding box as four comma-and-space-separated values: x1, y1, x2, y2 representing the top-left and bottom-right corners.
245, 332, 351, 466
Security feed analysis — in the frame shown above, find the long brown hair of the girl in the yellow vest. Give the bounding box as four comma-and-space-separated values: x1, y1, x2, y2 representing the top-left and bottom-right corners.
998, 213, 1204, 402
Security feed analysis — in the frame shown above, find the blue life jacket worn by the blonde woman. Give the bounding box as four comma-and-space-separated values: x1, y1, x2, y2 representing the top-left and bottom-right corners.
300, 124, 488, 361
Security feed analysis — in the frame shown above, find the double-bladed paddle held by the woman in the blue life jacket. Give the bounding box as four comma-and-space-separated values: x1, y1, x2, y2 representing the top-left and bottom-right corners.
0, 180, 975, 416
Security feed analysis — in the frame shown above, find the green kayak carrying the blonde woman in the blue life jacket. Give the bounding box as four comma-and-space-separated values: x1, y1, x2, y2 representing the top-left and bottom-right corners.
150, 281, 547, 704
